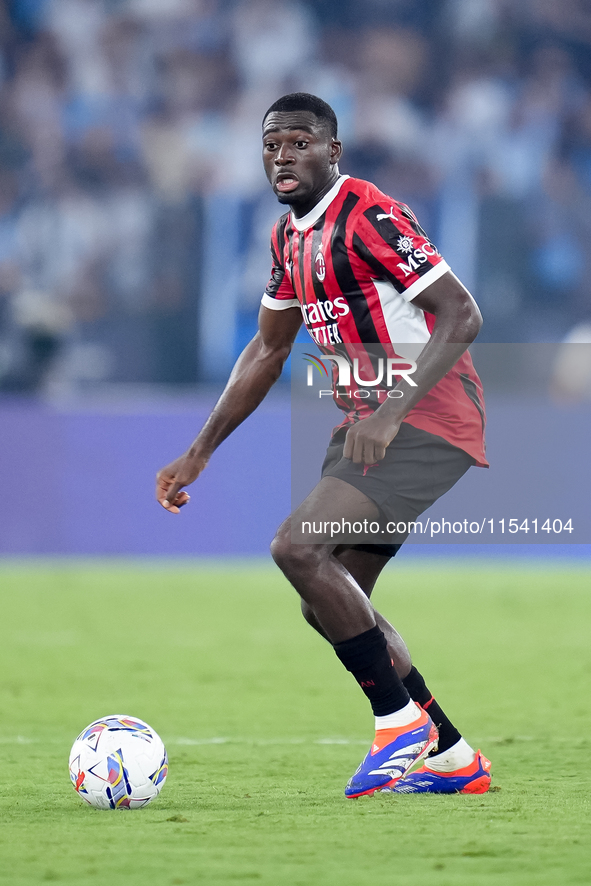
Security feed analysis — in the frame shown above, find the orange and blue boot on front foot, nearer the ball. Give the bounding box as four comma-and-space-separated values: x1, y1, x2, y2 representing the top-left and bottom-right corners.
345, 708, 437, 800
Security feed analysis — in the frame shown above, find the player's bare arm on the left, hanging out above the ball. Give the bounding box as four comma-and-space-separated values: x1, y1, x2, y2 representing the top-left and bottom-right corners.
156, 305, 302, 514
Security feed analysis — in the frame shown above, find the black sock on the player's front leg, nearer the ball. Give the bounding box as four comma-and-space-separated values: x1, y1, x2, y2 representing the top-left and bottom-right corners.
334, 625, 410, 717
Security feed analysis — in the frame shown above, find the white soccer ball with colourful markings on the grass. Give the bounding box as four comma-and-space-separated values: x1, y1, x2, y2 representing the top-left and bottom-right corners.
70, 714, 168, 809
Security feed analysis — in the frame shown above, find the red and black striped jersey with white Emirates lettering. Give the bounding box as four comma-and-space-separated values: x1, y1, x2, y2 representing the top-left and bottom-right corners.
262, 176, 488, 466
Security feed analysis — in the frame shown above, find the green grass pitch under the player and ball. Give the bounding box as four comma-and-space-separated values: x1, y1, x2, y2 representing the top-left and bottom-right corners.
0, 562, 591, 886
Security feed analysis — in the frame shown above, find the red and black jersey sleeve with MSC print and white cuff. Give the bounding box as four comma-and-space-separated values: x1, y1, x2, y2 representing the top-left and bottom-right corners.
353, 198, 449, 301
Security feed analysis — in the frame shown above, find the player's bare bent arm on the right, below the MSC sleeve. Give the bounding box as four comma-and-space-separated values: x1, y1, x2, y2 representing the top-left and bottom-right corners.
343, 271, 482, 465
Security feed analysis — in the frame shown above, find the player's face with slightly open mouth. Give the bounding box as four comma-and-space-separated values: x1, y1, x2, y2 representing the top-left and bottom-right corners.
263, 111, 342, 215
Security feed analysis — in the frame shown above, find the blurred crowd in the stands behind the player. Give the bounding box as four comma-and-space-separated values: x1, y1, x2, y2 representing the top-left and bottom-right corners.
0, 0, 591, 393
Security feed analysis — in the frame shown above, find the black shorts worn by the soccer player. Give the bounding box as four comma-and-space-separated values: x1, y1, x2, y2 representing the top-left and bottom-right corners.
322, 422, 476, 557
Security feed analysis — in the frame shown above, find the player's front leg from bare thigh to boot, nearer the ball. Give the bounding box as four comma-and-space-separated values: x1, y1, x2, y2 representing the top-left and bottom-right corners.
271, 477, 437, 797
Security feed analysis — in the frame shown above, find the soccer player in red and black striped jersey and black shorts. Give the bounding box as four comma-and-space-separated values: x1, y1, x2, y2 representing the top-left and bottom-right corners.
156, 93, 490, 798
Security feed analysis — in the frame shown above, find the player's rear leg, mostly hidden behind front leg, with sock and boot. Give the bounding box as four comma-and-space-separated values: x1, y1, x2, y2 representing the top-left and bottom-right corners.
302, 545, 490, 793
